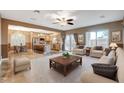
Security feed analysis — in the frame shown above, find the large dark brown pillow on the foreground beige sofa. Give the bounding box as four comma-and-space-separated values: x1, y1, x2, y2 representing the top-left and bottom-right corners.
92, 63, 117, 80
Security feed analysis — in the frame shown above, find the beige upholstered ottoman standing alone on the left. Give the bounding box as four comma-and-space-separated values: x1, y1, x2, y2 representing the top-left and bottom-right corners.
14, 57, 31, 74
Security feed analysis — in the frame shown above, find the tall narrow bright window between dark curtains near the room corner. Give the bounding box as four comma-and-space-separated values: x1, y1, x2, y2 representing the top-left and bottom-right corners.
65, 34, 76, 51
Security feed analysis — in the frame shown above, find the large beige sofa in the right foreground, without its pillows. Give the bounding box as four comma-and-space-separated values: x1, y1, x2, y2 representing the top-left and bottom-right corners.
81, 48, 124, 83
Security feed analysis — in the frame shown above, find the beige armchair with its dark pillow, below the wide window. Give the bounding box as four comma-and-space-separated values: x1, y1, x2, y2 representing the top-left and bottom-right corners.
90, 46, 104, 58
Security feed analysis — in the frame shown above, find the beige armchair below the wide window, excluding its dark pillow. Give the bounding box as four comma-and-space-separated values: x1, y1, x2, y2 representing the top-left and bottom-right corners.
90, 47, 104, 58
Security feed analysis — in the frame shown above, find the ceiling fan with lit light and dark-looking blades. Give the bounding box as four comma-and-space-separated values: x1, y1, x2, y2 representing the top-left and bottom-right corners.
53, 17, 74, 26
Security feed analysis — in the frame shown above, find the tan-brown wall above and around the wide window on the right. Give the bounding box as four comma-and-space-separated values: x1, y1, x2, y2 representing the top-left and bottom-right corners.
66, 20, 123, 44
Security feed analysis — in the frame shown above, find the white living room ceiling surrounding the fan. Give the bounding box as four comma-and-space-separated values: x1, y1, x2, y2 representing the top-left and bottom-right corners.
0, 10, 124, 30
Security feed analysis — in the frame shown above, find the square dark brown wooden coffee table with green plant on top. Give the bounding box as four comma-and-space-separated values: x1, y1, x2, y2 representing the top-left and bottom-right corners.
49, 56, 82, 76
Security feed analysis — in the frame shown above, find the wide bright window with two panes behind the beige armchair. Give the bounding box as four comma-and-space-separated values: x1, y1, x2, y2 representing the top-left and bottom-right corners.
86, 30, 109, 47
